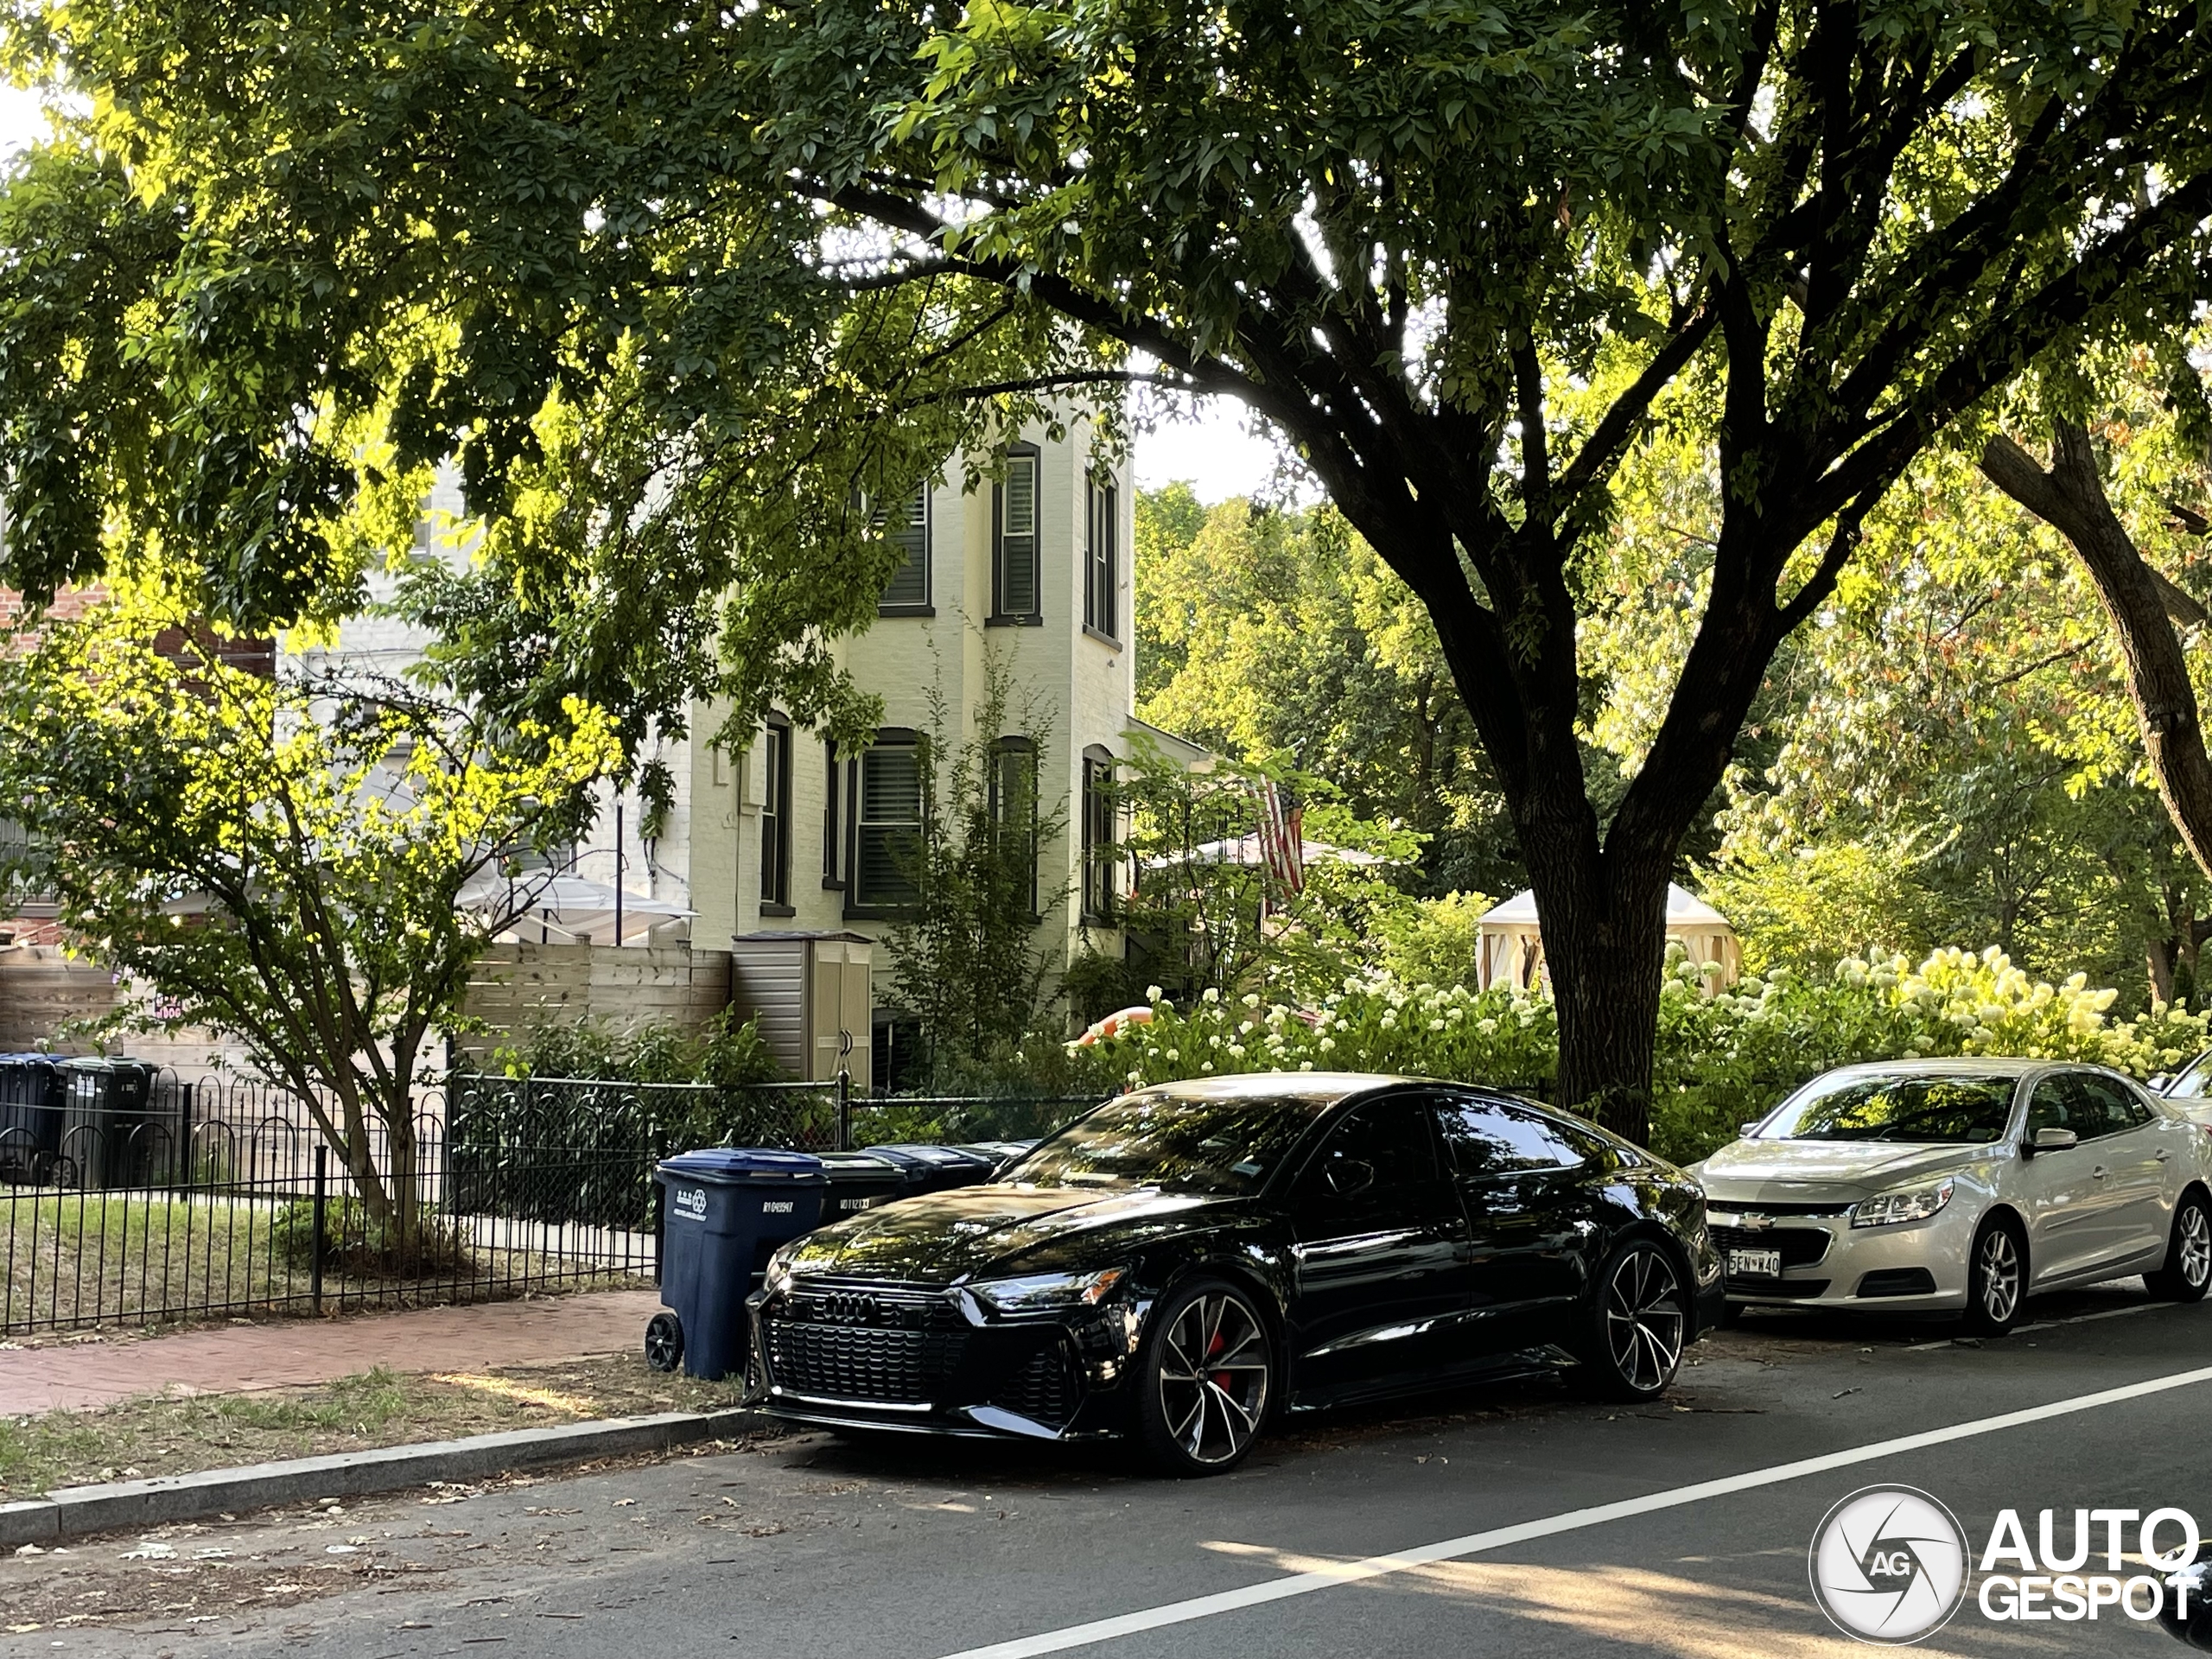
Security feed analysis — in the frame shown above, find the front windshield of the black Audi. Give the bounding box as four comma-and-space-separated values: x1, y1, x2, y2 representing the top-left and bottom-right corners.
998, 1090, 1330, 1194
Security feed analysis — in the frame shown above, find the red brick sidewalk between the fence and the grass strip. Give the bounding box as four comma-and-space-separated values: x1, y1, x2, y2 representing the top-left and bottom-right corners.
0, 1289, 661, 1418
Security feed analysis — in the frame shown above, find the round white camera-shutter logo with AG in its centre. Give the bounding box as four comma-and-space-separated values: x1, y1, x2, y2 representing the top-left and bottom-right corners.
1808, 1486, 1967, 1646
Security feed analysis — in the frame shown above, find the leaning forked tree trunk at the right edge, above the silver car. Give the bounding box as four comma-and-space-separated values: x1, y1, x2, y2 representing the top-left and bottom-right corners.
1982, 420, 2212, 874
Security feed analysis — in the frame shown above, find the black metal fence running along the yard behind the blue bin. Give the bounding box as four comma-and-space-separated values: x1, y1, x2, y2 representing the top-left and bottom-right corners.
0, 1059, 1095, 1334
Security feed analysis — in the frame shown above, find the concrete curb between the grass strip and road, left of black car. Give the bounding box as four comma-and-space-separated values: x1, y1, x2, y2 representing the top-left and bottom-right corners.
0, 1409, 763, 1548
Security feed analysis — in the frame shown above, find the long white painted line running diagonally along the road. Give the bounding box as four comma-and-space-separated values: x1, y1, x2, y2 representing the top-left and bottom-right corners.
944, 1365, 2212, 1659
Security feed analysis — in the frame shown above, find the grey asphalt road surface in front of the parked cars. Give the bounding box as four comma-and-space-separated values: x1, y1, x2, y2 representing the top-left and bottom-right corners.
13, 1285, 2212, 1659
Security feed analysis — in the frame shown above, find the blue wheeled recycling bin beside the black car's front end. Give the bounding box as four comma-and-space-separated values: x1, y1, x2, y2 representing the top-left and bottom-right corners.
646, 1146, 830, 1380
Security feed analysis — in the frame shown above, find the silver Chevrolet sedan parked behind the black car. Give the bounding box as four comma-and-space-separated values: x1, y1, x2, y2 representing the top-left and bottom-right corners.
1690, 1059, 2212, 1336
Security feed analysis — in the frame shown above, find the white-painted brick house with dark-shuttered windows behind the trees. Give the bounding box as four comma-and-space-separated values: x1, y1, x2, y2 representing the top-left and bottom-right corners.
307, 420, 1137, 1079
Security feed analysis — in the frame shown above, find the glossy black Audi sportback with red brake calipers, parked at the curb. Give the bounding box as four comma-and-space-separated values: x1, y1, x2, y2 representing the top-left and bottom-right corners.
752, 1073, 1721, 1476
